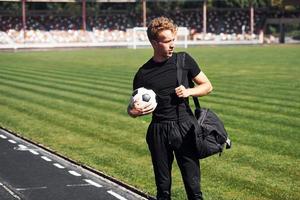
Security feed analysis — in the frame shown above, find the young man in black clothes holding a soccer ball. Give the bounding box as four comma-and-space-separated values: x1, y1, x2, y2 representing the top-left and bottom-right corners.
128, 17, 212, 200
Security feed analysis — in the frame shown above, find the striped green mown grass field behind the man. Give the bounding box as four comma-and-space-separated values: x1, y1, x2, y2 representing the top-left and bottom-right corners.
0, 45, 300, 200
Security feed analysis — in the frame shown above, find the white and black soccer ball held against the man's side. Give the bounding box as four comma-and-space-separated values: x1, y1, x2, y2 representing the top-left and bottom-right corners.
130, 87, 157, 108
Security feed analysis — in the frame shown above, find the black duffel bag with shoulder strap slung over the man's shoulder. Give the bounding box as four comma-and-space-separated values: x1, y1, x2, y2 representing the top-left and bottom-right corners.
177, 53, 231, 159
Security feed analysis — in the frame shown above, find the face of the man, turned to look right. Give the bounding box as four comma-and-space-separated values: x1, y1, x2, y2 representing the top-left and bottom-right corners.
153, 30, 175, 59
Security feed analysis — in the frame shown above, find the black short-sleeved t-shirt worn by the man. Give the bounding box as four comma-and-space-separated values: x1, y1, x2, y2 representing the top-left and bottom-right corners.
133, 53, 201, 121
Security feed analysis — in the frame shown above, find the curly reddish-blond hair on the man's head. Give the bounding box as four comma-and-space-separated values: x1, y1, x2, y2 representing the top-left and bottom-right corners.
147, 16, 177, 42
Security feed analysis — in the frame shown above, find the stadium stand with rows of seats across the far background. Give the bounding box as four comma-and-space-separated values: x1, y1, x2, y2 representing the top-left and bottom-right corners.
0, 1, 300, 47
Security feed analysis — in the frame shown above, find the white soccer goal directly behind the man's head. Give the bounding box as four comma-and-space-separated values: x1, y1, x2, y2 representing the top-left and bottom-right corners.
132, 27, 189, 49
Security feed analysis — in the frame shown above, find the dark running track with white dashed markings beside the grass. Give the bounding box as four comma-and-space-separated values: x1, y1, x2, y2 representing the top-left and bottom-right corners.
0, 129, 146, 200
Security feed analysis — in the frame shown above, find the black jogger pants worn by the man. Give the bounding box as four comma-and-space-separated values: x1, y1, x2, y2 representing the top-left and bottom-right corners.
146, 120, 203, 200
